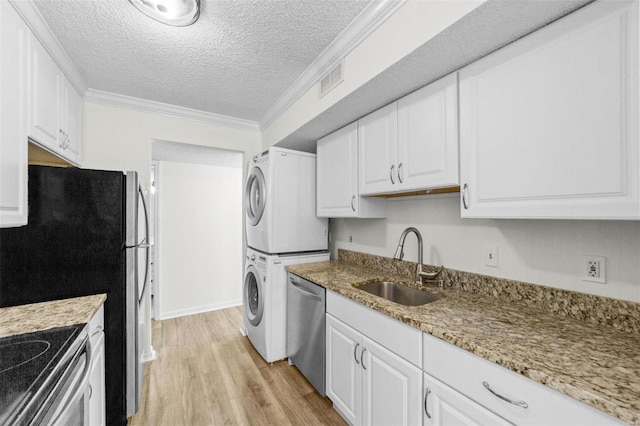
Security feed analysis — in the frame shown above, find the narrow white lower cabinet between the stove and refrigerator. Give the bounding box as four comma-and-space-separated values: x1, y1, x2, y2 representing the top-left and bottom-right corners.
89, 306, 106, 426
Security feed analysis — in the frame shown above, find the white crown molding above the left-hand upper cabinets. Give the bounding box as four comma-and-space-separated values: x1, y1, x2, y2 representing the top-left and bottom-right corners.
9, 0, 87, 96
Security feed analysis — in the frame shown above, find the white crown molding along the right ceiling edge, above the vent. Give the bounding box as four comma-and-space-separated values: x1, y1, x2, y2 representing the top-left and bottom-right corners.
260, 0, 407, 130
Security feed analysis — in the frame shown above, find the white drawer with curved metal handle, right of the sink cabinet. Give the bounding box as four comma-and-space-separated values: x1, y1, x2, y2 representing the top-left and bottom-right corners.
423, 333, 623, 426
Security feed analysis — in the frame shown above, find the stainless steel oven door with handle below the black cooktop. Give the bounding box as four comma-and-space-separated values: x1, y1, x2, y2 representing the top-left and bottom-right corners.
38, 340, 91, 426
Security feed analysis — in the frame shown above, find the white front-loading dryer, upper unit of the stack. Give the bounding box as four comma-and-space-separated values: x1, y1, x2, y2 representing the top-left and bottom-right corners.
245, 147, 329, 253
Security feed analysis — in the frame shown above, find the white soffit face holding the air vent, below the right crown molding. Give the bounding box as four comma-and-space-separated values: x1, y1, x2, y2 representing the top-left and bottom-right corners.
263, 0, 485, 149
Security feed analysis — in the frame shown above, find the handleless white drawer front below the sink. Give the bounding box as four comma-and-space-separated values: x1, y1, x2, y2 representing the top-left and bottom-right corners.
327, 290, 422, 367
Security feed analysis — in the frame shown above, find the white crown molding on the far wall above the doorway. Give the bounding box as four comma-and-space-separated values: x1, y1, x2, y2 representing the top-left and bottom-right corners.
83, 89, 260, 132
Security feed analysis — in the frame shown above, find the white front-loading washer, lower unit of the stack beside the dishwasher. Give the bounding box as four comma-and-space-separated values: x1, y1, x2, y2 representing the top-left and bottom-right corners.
242, 248, 329, 362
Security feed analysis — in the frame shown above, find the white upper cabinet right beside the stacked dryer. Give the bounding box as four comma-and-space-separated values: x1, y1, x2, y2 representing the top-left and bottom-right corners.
316, 123, 387, 218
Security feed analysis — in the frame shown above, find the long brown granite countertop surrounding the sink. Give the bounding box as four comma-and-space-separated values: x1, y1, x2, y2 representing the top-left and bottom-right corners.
287, 260, 640, 424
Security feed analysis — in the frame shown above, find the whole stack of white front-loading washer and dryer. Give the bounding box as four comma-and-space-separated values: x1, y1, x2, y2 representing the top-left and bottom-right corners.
243, 147, 329, 362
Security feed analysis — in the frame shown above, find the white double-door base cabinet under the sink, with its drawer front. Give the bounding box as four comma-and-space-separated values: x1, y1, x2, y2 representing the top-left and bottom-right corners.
326, 292, 422, 425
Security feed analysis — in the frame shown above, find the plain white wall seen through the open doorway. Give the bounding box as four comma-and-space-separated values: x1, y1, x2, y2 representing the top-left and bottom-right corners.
157, 161, 244, 319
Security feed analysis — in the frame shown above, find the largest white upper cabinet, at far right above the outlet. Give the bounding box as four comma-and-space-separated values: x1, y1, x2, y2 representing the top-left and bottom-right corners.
460, 1, 640, 219
